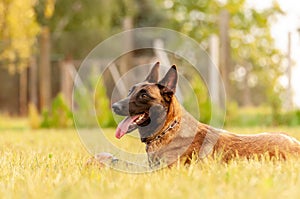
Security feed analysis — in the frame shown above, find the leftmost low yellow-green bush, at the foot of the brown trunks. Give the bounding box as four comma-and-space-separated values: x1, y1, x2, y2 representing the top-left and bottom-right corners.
41, 94, 74, 128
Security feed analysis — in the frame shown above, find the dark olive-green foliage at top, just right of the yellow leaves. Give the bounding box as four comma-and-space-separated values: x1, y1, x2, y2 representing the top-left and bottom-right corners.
49, 0, 121, 59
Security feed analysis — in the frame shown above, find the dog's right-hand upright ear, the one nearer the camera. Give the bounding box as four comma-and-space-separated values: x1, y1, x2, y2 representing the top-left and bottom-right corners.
157, 65, 178, 95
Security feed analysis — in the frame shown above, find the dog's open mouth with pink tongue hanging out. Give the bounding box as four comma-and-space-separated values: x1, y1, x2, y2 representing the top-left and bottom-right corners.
116, 112, 150, 139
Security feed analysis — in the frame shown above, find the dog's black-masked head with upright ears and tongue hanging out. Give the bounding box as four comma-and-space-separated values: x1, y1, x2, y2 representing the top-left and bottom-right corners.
112, 62, 178, 141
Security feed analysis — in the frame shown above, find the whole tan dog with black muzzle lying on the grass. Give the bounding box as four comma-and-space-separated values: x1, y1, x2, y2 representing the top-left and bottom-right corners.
112, 62, 300, 166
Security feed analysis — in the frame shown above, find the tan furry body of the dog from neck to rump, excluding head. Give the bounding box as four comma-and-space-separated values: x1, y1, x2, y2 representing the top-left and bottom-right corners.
146, 97, 300, 165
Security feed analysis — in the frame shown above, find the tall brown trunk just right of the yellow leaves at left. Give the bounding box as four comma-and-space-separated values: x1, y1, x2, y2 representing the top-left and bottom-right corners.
39, 26, 51, 110
